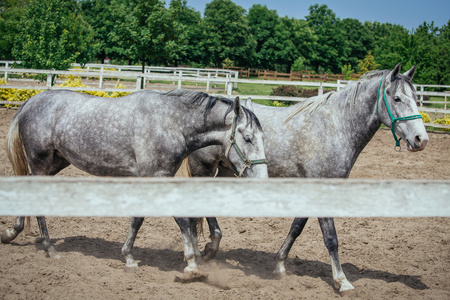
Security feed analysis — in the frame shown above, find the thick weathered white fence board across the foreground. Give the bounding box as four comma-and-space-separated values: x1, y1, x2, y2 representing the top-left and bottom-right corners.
0, 176, 450, 217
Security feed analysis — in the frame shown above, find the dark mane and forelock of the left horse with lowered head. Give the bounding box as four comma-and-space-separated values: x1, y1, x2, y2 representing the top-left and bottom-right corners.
164, 89, 262, 130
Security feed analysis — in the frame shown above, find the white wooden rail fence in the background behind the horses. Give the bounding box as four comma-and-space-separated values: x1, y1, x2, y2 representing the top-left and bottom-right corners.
0, 61, 450, 128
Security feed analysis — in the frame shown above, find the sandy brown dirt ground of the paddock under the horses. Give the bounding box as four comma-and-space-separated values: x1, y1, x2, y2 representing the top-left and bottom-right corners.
0, 108, 450, 300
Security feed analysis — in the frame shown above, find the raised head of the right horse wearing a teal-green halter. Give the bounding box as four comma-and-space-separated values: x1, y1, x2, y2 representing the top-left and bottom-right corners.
377, 63, 428, 152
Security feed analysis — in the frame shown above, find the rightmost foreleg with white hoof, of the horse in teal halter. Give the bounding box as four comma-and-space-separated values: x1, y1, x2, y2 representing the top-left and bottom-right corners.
319, 218, 354, 293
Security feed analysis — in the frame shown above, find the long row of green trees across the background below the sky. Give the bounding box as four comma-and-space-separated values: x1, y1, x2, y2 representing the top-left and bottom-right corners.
0, 0, 450, 85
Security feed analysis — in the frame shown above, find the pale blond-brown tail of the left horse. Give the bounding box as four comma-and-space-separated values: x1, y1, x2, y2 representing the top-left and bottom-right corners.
6, 105, 30, 176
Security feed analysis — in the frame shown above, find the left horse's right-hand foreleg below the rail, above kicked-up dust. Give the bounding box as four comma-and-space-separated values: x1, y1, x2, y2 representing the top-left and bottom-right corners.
175, 218, 201, 273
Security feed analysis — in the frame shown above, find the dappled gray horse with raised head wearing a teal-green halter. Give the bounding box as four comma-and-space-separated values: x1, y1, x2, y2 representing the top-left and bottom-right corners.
180, 64, 428, 292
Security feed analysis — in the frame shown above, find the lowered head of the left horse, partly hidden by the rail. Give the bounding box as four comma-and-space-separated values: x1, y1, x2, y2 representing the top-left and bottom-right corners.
225, 97, 268, 178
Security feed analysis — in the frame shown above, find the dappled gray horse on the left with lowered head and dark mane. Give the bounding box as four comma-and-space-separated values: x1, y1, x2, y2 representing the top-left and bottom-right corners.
1, 90, 267, 271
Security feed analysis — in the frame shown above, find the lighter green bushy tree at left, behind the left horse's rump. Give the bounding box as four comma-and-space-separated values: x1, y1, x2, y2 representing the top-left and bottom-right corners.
13, 0, 93, 70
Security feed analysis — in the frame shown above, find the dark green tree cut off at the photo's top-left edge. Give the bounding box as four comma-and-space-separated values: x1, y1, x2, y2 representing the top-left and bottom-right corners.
0, 0, 30, 60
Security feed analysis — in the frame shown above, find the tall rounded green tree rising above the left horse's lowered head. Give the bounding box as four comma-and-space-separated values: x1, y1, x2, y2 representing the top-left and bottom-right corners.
202, 0, 256, 67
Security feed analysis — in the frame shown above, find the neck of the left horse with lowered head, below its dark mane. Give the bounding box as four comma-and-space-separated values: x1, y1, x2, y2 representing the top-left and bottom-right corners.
185, 103, 234, 152
